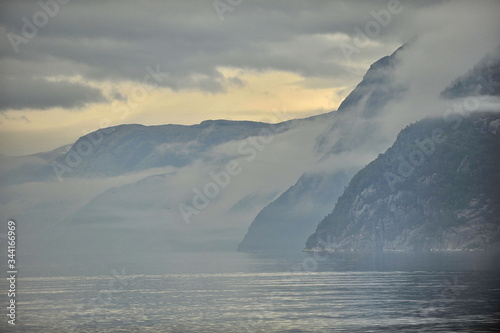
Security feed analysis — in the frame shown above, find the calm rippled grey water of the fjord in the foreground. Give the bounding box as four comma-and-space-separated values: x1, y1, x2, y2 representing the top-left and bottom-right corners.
0, 253, 500, 332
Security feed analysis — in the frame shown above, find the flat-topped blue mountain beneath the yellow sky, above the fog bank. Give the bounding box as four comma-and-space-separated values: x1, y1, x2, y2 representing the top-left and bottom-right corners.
51, 120, 285, 176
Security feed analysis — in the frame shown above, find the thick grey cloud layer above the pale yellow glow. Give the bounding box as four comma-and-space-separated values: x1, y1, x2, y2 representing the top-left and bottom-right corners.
0, 0, 494, 107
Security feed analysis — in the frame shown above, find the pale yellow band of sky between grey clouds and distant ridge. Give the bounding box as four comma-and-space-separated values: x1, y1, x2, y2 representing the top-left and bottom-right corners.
0, 68, 352, 156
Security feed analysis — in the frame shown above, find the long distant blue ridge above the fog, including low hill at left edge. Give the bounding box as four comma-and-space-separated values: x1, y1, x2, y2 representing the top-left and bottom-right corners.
0, 117, 314, 185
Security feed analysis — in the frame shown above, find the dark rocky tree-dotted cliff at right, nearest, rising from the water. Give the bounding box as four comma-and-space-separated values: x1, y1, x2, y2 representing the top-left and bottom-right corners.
306, 113, 500, 251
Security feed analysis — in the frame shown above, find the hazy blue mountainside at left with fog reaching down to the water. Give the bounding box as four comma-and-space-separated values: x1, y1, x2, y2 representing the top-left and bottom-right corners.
0, 113, 334, 254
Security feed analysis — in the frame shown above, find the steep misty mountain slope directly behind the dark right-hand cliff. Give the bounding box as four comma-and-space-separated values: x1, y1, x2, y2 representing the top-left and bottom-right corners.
238, 44, 408, 252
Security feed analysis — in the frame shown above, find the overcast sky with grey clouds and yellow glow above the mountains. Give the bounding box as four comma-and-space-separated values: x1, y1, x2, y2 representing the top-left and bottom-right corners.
0, 0, 500, 155
